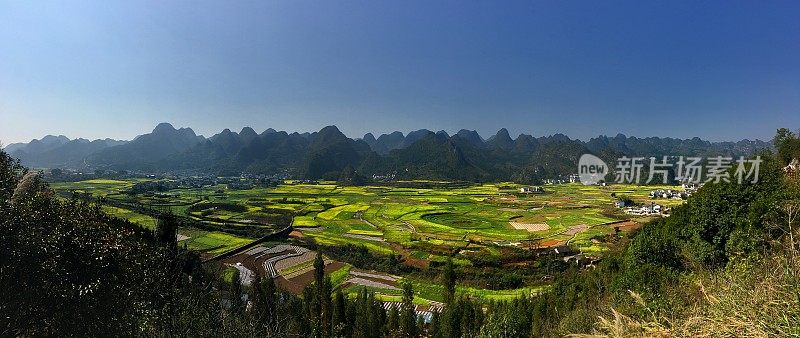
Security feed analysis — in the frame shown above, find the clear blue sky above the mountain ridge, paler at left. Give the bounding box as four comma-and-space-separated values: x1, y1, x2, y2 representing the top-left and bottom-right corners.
0, 0, 800, 144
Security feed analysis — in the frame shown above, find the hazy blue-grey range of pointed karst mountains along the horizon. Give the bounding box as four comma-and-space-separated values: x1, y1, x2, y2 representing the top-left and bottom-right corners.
5, 123, 771, 182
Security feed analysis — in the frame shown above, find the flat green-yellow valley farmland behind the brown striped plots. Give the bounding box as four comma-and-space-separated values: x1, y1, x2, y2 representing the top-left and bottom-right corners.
53, 180, 681, 261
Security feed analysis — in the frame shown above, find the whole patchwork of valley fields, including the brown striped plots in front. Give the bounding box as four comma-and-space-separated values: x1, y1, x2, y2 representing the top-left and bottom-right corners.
53, 180, 682, 306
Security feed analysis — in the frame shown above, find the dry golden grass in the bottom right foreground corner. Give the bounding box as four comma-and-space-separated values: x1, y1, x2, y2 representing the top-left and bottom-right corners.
572, 242, 800, 338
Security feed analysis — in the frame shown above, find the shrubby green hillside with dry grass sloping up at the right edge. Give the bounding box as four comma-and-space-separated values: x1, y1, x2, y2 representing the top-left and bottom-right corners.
520, 136, 800, 337
